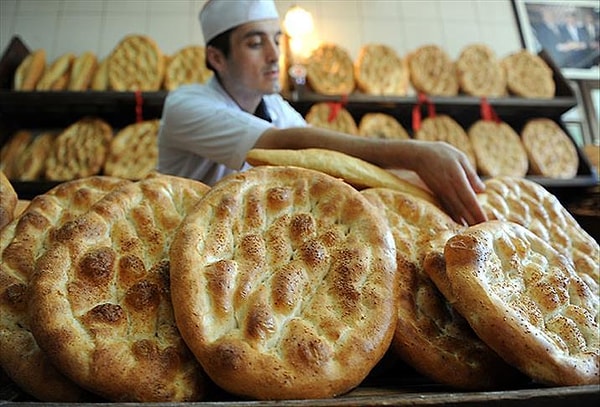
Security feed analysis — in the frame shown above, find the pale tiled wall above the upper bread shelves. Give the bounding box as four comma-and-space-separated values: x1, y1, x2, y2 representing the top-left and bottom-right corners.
0, 0, 520, 61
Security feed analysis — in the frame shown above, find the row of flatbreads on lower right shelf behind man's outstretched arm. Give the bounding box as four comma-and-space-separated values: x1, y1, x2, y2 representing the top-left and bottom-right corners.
305, 107, 580, 179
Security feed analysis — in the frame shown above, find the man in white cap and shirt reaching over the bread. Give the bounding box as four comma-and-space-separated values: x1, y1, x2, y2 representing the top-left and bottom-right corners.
158, 0, 485, 224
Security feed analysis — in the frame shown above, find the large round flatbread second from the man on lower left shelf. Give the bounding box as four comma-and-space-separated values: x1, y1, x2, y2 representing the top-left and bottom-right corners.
45, 117, 113, 181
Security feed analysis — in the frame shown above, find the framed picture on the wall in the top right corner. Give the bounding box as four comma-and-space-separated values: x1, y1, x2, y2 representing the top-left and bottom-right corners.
512, 0, 600, 80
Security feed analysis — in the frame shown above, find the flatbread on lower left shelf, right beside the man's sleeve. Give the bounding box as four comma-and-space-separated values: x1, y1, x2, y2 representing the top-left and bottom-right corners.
104, 120, 160, 180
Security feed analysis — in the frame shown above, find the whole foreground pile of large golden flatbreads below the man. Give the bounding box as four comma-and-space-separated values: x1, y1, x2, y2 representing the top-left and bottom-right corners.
0, 149, 600, 402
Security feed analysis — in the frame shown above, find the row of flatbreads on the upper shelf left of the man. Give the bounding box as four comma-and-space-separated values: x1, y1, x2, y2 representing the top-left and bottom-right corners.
13, 34, 212, 91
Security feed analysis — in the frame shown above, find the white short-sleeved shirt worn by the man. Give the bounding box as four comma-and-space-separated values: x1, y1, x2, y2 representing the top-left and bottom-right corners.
158, 77, 307, 185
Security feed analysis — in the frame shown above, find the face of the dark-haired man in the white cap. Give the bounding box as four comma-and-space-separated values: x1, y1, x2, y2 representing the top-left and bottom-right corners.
222, 20, 281, 95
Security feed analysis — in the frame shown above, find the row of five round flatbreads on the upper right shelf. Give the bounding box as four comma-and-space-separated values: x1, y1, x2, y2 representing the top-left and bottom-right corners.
306, 43, 556, 99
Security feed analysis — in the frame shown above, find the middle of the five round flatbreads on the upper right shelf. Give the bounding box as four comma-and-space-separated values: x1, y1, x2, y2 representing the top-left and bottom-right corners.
407, 45, 459, 96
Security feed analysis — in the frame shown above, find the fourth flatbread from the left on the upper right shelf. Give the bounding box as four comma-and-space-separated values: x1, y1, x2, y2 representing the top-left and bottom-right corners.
456, 44, 506, 97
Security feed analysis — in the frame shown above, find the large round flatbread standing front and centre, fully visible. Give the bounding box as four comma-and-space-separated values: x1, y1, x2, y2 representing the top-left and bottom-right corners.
171, 166, 396, 399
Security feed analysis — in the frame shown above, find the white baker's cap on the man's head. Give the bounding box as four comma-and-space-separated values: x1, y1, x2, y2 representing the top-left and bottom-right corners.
200, 0, 279, 44
